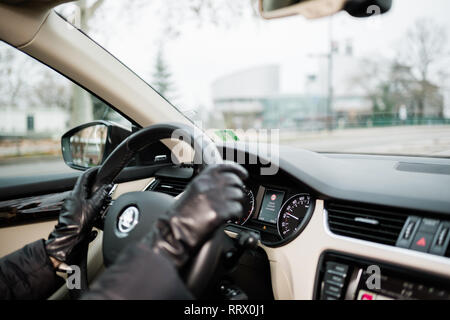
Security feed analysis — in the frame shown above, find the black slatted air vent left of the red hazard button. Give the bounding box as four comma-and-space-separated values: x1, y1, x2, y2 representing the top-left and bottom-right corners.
327, 202, 408, 246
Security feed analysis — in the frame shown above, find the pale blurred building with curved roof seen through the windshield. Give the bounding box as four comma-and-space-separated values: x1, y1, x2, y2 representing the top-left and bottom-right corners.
210, 58, 371, 130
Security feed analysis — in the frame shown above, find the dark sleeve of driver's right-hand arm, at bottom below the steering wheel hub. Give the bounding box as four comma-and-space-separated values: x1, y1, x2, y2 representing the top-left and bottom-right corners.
82, 243, 193, 300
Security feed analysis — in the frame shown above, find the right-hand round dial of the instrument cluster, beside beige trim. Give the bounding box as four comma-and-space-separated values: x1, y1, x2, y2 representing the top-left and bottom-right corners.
277, 193, 311, 239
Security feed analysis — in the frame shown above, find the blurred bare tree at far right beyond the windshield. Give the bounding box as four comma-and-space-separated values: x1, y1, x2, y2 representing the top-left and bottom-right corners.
352, 19, 448, 122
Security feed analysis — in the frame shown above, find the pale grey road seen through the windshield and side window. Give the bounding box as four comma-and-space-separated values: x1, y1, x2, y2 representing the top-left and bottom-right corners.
0, 126, 450, 178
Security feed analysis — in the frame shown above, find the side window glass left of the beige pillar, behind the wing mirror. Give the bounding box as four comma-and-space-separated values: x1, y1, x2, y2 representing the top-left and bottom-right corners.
0, 41, 131, 178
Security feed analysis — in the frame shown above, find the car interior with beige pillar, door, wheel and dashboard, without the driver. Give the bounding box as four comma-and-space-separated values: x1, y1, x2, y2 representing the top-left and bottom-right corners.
0, 0, 450, 300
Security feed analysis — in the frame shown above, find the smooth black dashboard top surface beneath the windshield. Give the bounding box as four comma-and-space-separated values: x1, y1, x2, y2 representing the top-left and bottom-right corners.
219, 142, 450, 215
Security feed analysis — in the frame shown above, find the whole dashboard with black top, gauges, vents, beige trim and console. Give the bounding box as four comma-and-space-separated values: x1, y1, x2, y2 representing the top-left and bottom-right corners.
145, 144, 450, 300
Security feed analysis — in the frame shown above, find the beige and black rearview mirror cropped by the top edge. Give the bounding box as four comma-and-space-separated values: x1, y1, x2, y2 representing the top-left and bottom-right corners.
259, 0, 392, 19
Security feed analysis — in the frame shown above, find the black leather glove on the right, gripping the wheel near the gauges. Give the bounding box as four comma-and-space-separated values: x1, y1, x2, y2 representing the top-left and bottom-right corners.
142, 162, 248, 270
